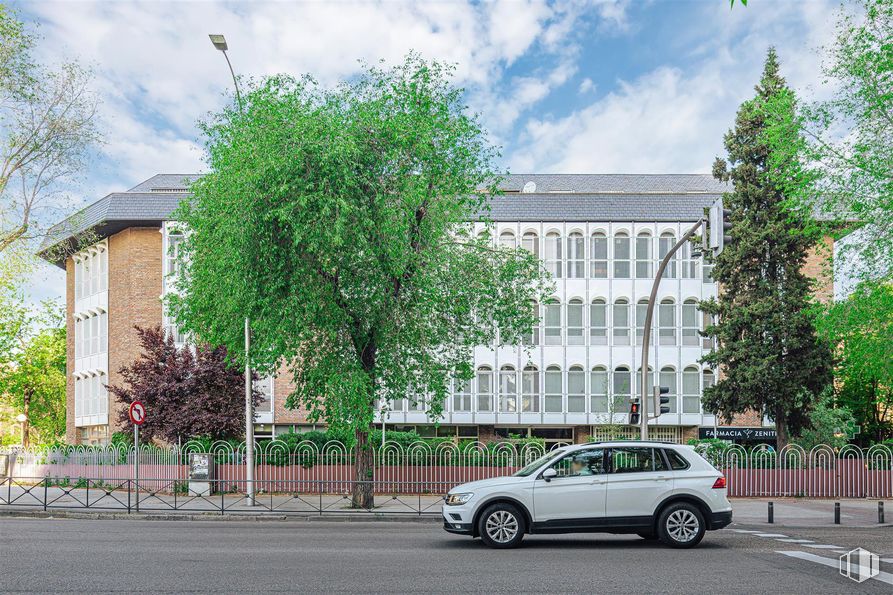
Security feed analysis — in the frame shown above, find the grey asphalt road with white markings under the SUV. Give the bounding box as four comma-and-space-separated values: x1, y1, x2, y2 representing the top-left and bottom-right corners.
0, 517, 893, 595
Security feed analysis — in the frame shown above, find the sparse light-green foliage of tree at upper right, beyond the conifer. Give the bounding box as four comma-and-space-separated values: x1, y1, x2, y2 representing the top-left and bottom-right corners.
765, 0, 893, 277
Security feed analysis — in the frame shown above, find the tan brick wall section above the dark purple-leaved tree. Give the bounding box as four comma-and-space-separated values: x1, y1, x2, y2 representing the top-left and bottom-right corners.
109, 227, 162, 435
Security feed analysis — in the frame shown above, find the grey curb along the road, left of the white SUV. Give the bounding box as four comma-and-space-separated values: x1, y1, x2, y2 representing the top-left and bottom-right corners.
0, 508, 443, 524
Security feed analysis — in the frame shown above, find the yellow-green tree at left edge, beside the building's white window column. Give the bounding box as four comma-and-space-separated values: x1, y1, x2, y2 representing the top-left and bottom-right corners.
0, 302, 66, 446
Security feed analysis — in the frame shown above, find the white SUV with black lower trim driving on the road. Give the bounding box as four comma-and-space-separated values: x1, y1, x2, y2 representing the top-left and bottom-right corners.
443, 441, 732, 548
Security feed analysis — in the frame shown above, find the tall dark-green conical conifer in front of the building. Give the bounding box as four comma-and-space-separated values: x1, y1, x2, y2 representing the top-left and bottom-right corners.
702, 49, 830, 447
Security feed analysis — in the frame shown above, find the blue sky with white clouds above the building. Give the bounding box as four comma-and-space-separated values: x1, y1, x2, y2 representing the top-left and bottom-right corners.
19, 0, 839, 300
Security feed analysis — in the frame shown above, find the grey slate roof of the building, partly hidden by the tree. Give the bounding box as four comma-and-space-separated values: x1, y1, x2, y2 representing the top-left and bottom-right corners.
39, 174, 728, 266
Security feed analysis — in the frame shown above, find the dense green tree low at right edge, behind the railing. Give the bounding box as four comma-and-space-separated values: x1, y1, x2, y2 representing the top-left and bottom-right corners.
816, 281, 893, 442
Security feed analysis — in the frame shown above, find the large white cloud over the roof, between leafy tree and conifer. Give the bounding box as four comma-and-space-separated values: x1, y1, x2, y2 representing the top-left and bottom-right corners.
509, 2, 835, 173
